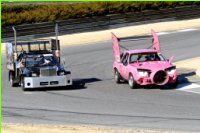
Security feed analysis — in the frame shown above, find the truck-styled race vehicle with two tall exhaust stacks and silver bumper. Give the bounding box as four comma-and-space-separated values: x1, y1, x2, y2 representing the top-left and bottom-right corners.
6, 24, 72, 90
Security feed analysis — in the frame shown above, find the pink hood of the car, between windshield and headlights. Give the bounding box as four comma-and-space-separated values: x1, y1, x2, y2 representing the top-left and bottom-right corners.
131, 61, 172, 71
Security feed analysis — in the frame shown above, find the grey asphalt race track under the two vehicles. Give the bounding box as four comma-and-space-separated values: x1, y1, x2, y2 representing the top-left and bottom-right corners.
2, 29, 200, 131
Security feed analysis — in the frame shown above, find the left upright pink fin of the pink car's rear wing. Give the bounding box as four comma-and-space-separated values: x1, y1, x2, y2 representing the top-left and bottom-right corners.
111, 33, 121, 63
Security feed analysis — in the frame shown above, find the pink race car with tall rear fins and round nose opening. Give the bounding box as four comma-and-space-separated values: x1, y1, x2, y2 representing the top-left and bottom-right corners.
112, 30, 178, 88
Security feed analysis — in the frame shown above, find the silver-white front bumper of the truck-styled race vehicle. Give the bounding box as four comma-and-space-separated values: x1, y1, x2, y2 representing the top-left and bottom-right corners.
24, 74, 72, 88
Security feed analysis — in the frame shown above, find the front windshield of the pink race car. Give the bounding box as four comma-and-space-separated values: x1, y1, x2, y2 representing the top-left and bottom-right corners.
129, 52, 165, 63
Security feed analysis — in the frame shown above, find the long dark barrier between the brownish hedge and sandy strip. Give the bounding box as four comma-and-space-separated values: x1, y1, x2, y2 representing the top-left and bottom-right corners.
2, 6, 200, 42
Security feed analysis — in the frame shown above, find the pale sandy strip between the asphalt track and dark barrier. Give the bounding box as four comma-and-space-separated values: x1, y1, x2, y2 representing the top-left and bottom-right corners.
2, 19, 200, 53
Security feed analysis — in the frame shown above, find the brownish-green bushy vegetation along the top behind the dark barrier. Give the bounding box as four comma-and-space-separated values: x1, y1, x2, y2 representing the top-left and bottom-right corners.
1, 2, 200, 27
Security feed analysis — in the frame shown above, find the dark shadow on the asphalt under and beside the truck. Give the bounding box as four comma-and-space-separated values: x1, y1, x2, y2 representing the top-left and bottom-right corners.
27, 78, 102, 91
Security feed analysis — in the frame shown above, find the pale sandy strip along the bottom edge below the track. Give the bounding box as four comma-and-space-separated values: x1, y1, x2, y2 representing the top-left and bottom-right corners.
2, 124, 193, 133
